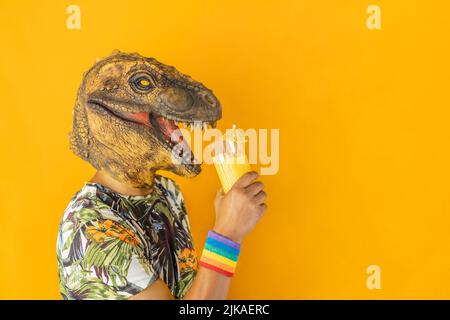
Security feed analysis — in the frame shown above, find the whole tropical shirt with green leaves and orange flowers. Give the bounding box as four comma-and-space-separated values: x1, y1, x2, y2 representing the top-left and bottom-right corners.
57, 175, 198, 299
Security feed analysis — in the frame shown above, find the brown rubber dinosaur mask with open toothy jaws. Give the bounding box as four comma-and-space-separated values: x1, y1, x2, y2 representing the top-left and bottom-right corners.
70, 52, 222, 188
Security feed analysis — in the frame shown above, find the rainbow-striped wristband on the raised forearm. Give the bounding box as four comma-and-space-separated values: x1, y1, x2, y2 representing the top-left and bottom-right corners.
199, 231, 241, 277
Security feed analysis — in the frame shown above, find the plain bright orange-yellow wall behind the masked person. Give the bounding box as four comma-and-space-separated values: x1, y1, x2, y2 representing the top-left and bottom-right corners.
0, 0, 450, 299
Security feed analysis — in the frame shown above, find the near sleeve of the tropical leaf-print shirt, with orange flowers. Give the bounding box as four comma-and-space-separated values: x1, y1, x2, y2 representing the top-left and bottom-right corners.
57, 208, 158, 300
